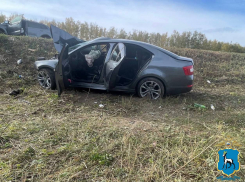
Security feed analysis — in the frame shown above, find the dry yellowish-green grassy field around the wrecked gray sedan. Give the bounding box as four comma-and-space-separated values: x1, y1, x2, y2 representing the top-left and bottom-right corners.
0, 36, 245, 182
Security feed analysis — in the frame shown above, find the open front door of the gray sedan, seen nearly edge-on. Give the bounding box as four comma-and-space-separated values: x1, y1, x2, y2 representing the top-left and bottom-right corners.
55, 44, 68, 96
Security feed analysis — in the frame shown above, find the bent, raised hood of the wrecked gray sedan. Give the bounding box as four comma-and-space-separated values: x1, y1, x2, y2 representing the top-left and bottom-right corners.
50, 25, 85, 53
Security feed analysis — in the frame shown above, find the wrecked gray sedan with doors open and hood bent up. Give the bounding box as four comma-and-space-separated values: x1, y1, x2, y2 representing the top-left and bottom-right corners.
35, 25, 193, 99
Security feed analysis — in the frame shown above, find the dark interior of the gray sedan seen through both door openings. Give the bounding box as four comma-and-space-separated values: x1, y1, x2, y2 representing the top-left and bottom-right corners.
68, 44, 152, 86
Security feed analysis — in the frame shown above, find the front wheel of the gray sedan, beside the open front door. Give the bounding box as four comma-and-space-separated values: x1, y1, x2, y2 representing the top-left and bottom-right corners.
37, 68, 56, 90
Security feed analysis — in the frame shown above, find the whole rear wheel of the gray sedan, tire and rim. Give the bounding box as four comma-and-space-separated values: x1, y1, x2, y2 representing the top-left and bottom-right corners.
137, 77, 165, 100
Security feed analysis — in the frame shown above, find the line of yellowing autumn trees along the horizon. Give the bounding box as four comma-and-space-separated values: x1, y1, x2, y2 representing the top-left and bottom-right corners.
0, 14, 245, 53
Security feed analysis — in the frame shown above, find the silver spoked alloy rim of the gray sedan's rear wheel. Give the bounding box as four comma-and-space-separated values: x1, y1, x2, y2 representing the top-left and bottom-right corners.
140, 81, 162, 100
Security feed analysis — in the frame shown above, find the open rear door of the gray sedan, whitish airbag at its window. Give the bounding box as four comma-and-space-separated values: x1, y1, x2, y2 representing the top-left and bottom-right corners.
104, 43, 126, 90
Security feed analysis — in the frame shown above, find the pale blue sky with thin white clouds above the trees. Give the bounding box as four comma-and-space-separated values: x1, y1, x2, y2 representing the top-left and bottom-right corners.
0, 0, 245, 46
